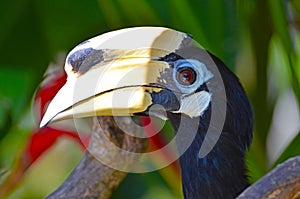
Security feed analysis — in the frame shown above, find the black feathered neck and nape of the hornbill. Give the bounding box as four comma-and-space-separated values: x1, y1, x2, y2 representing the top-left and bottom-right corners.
168, 56, 253, 199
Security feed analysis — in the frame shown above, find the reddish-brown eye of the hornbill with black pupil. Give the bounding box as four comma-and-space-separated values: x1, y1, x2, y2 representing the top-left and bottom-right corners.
176, 66, 197, 86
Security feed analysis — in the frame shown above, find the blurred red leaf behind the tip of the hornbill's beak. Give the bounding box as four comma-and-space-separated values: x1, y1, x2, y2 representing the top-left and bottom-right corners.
0, 66, 90, 196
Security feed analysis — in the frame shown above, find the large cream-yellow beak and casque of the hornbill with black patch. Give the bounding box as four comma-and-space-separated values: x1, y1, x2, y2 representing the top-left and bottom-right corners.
40, 27, 190, 127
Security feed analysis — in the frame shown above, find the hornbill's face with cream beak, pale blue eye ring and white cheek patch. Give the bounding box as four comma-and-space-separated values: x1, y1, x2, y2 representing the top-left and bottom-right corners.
41, 27, 218, 126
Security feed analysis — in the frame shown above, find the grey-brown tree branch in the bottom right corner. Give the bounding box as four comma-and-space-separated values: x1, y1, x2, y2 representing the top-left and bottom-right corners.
237, 156, 300, 199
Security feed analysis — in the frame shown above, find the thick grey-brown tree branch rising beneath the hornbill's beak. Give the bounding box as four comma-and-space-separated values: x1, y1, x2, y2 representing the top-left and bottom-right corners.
47, 117, 146, 199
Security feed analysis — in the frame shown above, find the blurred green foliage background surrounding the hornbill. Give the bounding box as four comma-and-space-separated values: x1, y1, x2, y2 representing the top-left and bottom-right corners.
0, 0, 300, 199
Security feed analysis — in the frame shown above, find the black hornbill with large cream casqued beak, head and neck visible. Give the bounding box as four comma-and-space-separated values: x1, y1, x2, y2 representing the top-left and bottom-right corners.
41, 27, 253, 199
